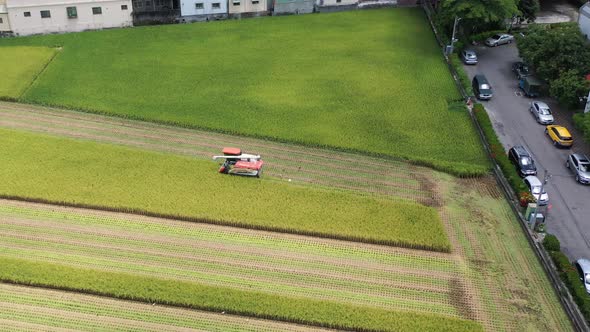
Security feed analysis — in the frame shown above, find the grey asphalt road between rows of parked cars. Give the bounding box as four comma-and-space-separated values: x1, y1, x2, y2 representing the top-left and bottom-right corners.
465, 44, 590, 260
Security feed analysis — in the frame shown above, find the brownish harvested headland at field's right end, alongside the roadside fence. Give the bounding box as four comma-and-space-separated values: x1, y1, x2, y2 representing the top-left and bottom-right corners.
440, 175, 572, 331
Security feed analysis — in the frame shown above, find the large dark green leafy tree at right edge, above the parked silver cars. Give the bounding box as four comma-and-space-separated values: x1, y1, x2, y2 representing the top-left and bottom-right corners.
517, 23, 590, 81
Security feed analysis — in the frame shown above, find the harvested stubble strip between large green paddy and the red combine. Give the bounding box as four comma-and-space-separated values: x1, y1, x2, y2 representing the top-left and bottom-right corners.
0, 102, 440, 206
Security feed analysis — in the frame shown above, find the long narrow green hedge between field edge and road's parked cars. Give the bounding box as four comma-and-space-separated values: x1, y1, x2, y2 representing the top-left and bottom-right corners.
473, 103, 528, 193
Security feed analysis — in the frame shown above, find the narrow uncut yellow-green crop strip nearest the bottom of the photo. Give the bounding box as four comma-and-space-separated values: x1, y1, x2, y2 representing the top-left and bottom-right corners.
0, 257, 482, 331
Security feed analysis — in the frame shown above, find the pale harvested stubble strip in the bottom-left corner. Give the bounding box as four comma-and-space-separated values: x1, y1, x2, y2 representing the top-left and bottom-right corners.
0, 284, 336, 332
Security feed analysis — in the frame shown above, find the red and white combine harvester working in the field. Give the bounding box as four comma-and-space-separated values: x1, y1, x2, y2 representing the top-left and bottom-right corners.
213, 148, 264, 178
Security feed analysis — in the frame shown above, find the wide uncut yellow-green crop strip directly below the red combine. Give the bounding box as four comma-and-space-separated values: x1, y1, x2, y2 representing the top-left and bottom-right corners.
0, 129, 450, 251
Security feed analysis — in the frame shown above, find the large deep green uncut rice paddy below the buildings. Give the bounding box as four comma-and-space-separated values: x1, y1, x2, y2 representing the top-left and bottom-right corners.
0, 8, 488, 174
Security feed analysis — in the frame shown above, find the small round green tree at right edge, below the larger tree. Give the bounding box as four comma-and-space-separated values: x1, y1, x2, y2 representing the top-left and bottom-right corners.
549, 69, 588, 108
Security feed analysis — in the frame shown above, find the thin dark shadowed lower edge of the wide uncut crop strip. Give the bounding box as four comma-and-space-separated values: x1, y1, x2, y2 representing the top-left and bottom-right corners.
0, 194, 451, 253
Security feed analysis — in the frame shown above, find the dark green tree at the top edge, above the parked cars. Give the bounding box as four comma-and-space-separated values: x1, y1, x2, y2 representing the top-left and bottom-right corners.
440, 0, 519, 34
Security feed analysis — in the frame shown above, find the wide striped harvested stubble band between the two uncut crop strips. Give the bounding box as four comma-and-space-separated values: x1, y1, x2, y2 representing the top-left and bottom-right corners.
0, 201, 470, 317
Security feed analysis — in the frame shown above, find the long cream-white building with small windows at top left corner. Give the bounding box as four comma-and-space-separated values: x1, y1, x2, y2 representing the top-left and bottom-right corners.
6, 0, 133, 36
